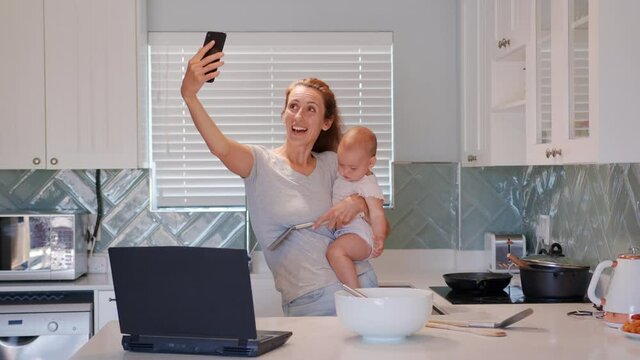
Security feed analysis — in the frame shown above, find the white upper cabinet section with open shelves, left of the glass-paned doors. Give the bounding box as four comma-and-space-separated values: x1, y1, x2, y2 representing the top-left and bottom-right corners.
460, 0, 533, 166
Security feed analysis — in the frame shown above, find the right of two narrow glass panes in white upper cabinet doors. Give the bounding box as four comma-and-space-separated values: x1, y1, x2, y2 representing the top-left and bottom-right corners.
568, 0, 589, 139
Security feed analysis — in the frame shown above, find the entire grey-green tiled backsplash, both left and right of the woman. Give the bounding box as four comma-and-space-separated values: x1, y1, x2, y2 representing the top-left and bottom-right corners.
0, 163, 640, 263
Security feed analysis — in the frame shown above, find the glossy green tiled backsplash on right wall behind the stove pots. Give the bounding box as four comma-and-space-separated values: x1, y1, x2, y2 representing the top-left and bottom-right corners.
460, 164, 640, 265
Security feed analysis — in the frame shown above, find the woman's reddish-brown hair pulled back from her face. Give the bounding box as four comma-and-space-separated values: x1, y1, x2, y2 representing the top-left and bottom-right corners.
283, 78, 342, 152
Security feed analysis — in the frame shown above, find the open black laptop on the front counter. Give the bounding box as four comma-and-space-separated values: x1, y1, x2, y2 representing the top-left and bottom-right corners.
109, 246, 293, 357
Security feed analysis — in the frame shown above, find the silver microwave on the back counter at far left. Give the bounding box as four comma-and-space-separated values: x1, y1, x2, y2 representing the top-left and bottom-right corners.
0, 213, 91, 281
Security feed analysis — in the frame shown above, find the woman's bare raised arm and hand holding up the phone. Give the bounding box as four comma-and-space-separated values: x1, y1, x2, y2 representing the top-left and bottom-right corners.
180, 41, 253, 177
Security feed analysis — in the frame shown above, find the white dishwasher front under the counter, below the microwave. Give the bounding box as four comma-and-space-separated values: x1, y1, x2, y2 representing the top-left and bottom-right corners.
0, 291, 93, 360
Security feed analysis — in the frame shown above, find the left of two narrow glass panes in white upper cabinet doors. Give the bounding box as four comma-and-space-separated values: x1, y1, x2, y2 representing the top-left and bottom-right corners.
536, 0, 552, 144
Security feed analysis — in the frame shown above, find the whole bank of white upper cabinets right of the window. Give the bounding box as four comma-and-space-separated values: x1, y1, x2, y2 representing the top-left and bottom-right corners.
461, 0, 640, 165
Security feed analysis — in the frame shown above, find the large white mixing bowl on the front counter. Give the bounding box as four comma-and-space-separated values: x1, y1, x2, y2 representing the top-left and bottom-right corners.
335, 288, 433, 342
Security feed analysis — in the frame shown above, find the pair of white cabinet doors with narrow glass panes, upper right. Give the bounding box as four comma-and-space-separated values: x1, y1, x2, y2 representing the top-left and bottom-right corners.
528, 0, 597, 164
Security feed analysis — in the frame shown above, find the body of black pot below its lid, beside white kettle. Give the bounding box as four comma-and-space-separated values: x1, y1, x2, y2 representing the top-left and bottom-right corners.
520, 268, 591, 300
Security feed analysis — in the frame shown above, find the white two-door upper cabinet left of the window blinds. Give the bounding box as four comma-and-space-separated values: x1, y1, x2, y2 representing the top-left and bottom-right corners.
0, 0, 146, 169
